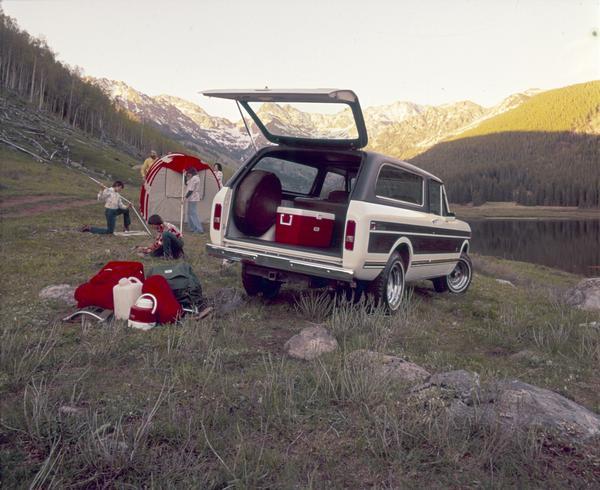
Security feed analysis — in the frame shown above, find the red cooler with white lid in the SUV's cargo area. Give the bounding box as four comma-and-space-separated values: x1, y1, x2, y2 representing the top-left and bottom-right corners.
275, 206, 335, 248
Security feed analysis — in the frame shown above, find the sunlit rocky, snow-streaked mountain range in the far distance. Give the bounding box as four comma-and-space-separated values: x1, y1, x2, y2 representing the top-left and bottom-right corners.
88, 78, 538, 166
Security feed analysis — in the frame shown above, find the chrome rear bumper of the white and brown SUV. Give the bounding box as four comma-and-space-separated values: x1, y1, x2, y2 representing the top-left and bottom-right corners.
206, 243, 354, 282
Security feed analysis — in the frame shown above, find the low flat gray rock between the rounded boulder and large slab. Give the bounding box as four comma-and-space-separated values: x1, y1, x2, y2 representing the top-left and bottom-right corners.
348, 349, 430, 383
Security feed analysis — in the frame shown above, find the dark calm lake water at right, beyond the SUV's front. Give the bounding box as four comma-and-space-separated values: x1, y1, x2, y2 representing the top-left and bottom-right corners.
468, 219, 600, 276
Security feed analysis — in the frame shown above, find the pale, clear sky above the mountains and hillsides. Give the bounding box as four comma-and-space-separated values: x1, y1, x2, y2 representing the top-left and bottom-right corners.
0, 0, 600, 119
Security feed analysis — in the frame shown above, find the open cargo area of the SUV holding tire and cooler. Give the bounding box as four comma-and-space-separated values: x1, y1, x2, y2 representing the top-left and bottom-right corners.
226, 148, 362, 257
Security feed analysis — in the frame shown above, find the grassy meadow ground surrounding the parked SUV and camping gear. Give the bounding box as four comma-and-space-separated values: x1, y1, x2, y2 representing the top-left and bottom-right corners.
0, 151, 600, 488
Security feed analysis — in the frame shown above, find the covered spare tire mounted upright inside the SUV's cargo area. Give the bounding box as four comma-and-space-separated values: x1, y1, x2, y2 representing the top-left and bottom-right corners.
233, 170, 281, 236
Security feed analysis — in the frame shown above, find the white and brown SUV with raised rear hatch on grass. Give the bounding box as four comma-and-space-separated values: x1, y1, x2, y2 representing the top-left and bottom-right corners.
204, 89, 472, 311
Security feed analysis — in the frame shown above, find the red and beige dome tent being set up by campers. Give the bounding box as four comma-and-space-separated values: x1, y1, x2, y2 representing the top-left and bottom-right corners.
140, 153, 220, 224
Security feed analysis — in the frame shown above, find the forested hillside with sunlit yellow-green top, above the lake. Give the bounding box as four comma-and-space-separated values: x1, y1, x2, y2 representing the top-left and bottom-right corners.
411, 81, 600, 207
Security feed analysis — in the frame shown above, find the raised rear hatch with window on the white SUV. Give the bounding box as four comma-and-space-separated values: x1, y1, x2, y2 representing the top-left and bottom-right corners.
202, 89, 368, 150
